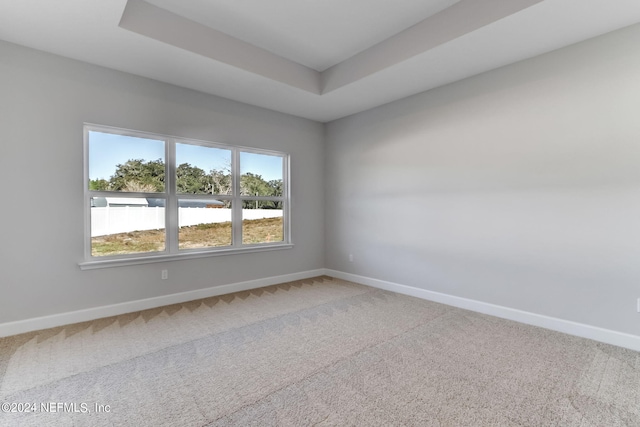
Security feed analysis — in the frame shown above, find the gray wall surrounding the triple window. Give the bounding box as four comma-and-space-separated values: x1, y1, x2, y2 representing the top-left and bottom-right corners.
0, 42, 324, 323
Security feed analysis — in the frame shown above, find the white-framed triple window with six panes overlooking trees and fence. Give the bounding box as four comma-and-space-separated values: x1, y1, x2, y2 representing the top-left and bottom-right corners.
80, 125, 291, 268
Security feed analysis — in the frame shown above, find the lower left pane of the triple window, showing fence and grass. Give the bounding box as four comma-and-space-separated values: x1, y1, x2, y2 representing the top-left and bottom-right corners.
91, 197, 165, 256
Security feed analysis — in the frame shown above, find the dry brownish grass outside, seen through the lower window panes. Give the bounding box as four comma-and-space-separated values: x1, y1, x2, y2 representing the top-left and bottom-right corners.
91, 218, 283, 256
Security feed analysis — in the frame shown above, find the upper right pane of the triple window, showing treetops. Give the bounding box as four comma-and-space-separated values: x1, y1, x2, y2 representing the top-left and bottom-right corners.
240, 152, 283, 197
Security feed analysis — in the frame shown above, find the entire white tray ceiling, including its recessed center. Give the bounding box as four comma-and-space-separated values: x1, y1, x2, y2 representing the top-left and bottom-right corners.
0, 0, 640, 122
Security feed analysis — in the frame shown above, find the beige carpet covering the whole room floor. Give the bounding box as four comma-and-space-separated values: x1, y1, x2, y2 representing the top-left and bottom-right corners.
0, 277, 640, 427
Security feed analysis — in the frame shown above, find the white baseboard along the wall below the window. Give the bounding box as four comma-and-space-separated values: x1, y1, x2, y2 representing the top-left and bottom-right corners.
0, 269, 325, 337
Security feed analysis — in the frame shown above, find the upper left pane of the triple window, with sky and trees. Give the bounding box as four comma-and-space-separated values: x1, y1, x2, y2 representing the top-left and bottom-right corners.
88, 131, 165, 193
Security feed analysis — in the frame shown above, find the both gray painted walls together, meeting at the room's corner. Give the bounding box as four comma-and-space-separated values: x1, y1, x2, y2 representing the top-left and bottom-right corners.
0, 22, 640, 335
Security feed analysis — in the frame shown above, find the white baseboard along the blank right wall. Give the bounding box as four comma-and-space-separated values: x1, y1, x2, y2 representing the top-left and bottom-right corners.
324, 269, 640, 351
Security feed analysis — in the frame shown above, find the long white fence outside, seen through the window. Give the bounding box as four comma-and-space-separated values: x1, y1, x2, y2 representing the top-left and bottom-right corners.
91, 206, 282, 237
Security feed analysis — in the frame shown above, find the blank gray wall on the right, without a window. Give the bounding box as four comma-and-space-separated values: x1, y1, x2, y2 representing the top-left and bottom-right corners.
325, 26, 640, 334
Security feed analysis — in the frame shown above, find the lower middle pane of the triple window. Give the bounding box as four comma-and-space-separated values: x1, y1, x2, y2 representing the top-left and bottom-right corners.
178, 199, 233, 249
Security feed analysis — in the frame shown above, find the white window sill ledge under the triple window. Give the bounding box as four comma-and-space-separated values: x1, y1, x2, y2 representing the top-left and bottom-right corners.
78, 243, 293, 270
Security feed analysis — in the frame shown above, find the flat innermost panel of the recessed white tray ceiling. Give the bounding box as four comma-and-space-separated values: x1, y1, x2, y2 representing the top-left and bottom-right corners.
147, 0, 460, 71
